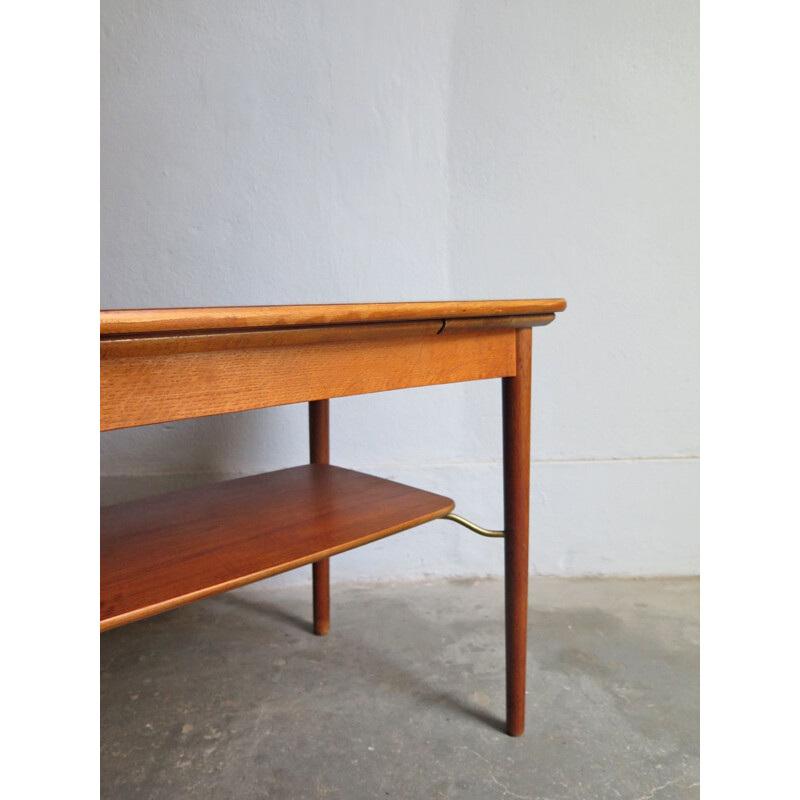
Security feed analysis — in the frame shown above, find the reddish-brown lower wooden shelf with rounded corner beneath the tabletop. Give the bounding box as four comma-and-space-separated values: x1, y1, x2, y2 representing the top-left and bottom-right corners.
100, 464, 454, 631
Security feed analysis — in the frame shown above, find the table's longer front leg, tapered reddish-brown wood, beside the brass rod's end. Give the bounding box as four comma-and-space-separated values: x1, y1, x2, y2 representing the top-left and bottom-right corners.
503, 328, 531, 736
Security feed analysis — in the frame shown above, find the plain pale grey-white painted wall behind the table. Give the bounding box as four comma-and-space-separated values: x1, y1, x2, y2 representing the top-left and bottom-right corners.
101, 0, 699, 582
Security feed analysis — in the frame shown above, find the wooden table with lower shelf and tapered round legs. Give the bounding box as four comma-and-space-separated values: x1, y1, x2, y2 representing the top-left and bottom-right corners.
100, 299, 566, 736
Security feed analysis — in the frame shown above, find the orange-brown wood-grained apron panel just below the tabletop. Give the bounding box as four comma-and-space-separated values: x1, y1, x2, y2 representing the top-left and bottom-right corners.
100, 328, 516, 430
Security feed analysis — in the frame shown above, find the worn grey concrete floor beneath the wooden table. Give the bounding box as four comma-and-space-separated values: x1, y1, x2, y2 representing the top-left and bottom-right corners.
101, 578, 699, 800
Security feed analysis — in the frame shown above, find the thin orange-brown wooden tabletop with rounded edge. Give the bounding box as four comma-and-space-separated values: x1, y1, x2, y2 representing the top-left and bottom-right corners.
100, 298, 567, 336
